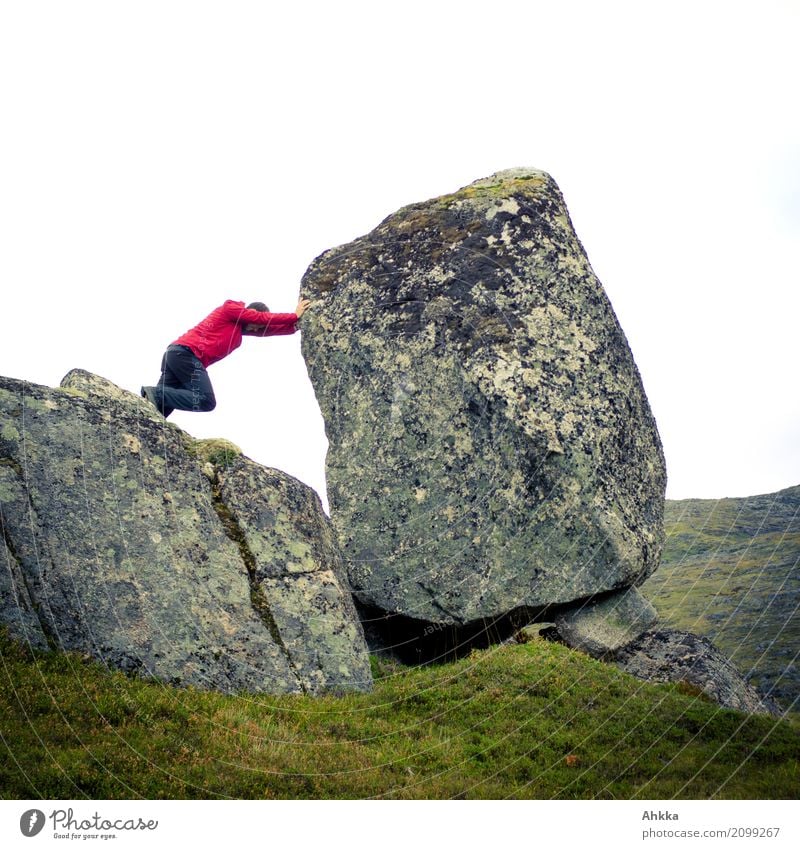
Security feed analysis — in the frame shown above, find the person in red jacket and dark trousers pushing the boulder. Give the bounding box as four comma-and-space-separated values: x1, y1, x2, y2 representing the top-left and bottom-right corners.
141, 299, 311, 418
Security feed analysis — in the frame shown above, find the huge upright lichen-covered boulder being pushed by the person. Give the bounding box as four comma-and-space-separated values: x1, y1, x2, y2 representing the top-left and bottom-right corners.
302, 171, 666, 624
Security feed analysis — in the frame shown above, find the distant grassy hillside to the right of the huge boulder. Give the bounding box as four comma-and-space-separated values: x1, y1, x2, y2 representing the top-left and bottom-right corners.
642, 486, 800, 709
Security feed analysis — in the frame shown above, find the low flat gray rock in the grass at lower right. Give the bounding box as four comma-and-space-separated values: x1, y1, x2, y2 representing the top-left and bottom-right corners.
615, 628, 781, 715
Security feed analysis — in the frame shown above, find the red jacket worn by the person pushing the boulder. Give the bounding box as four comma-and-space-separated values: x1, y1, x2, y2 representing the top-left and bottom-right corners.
172, 301, 298, 368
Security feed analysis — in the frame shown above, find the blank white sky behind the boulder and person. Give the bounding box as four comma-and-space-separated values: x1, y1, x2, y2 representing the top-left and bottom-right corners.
0, 0, 800, 498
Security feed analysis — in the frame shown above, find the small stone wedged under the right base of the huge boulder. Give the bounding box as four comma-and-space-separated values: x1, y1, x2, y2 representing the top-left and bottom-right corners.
554, 587, 658, 659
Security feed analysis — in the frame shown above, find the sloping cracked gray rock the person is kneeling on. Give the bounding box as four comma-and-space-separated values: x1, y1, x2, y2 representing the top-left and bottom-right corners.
0, 371, 371, 693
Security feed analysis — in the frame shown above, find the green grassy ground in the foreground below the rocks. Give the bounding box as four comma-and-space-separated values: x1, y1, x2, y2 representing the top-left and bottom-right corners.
0, 636, 800, 799
